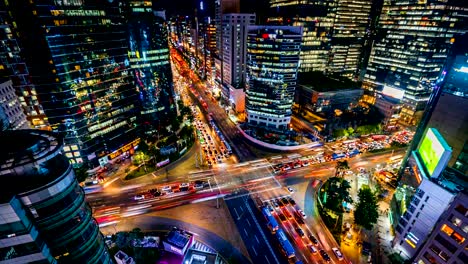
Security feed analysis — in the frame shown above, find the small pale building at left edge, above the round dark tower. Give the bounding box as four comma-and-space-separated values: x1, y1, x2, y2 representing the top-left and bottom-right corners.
0, 80, 29, 129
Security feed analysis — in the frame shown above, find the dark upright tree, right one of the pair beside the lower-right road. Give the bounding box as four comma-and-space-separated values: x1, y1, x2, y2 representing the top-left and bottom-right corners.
354, 186, 379, 230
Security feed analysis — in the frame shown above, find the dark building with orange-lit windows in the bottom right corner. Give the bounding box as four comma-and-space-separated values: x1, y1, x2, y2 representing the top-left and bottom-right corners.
414, 193, 468, 264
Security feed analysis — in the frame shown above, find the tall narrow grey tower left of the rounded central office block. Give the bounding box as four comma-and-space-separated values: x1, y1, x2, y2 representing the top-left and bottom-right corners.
222, 14, 255, 99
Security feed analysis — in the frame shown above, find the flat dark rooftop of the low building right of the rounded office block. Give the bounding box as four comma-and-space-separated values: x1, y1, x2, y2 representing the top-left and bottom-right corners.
298, 72, 361, 92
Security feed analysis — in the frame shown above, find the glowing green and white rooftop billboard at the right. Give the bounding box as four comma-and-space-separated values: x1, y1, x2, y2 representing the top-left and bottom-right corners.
416, 128, 452, 178
